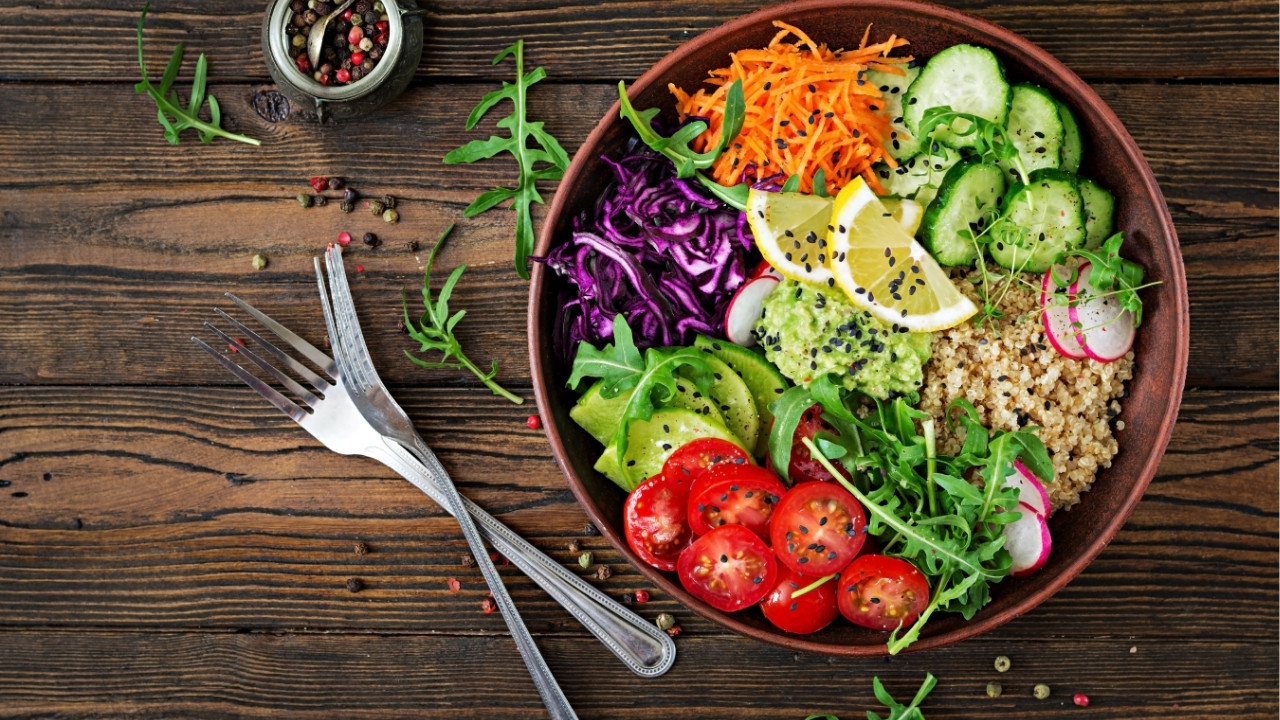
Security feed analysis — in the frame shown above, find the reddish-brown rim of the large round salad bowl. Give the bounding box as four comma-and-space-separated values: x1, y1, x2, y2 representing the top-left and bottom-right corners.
527, 0, 1190, 657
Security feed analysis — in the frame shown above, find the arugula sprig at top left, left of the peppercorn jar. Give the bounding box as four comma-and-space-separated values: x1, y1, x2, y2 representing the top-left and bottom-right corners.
133, 3, 261, 145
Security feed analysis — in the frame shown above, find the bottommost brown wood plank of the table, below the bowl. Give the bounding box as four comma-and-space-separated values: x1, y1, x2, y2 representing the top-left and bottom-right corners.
0, 630, 1277, 720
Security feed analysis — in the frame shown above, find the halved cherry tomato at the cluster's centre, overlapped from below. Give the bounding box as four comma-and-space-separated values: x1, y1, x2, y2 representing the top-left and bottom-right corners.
689, 465, 787, 542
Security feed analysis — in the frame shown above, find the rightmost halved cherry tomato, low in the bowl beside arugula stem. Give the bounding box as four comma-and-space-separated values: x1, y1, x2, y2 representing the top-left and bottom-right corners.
837, 555, 929, 630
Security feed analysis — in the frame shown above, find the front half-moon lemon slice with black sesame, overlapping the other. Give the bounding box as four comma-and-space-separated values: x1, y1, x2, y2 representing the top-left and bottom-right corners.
828, 178, 978, 332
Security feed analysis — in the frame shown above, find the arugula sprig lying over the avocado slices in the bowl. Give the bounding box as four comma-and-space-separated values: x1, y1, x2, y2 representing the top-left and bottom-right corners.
567, 313, 714, 492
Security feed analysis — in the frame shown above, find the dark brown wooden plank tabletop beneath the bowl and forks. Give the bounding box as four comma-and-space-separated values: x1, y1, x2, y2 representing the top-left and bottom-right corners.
0, 0, 1277, 720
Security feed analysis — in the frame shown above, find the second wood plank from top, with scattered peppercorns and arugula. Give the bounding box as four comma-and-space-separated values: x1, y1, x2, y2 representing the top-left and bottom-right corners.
0, 86, 1280, 387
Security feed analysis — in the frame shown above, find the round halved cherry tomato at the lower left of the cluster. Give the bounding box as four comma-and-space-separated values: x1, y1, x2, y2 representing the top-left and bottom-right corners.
676, 525, 778, 612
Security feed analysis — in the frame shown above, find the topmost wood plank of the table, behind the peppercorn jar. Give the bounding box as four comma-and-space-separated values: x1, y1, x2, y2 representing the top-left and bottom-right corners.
0, 0, 1277, 82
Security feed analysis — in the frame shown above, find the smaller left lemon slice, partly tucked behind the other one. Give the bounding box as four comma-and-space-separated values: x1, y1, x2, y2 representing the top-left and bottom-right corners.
746, 188, 835, 286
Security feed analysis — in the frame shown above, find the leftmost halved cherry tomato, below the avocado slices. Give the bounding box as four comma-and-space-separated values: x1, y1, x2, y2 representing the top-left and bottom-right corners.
622, 474, 694, 570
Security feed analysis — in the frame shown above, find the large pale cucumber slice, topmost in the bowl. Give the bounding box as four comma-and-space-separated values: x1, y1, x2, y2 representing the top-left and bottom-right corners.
902, 45, 1010, 147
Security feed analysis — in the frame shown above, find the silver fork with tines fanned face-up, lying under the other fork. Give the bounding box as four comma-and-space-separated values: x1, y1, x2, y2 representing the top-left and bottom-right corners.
192, 285, 675, 707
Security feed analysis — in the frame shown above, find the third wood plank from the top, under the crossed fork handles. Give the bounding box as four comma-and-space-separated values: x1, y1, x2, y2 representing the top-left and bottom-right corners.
0, 387, 1280, 641
